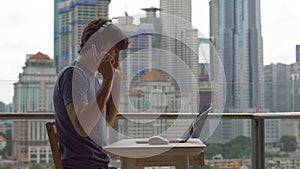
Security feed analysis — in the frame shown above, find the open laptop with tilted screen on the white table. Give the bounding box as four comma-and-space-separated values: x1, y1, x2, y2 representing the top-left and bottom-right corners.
135, 103, 212, 144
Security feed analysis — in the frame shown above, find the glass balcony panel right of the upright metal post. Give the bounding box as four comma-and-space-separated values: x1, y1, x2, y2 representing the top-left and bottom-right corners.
265, 119, 300, 168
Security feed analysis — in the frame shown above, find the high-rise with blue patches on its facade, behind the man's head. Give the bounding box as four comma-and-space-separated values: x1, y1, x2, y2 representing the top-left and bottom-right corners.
54, 0, 110, 71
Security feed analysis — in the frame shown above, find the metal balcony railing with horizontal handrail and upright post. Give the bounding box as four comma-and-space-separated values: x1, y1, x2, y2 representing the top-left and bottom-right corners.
0, 112, 300, 169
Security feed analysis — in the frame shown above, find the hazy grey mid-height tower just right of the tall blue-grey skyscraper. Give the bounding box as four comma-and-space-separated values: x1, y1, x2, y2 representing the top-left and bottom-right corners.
264, 63, 292, 143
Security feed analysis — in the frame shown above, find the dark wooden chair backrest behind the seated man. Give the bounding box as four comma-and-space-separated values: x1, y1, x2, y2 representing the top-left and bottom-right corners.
46, 122, 63, 169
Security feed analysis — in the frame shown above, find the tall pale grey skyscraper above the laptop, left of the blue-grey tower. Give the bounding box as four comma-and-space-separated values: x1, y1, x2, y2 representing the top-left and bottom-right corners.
159, 0, 199, 111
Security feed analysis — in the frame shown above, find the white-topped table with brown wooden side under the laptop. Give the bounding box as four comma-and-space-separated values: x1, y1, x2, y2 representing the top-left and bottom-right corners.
103, 139, 205, 169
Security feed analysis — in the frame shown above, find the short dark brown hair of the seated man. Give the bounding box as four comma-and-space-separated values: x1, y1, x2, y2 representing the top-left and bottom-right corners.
78, 18, 130, 53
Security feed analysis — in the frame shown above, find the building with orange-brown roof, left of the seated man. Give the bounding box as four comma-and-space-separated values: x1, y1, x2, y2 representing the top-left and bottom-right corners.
12, 52, 57, 163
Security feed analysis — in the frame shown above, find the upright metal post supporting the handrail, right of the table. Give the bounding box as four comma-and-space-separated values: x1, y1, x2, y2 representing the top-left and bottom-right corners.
252, 118, 265, 169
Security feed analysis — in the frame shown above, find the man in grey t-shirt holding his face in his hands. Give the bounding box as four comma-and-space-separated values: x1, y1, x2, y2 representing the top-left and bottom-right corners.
53, 18, 129, 169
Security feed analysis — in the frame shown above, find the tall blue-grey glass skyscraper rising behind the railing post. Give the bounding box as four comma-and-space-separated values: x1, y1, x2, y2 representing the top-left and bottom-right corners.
209, 0, 264, 110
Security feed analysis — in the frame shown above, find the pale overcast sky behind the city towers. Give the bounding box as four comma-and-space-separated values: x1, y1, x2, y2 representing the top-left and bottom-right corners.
0, 0, 300, 104
